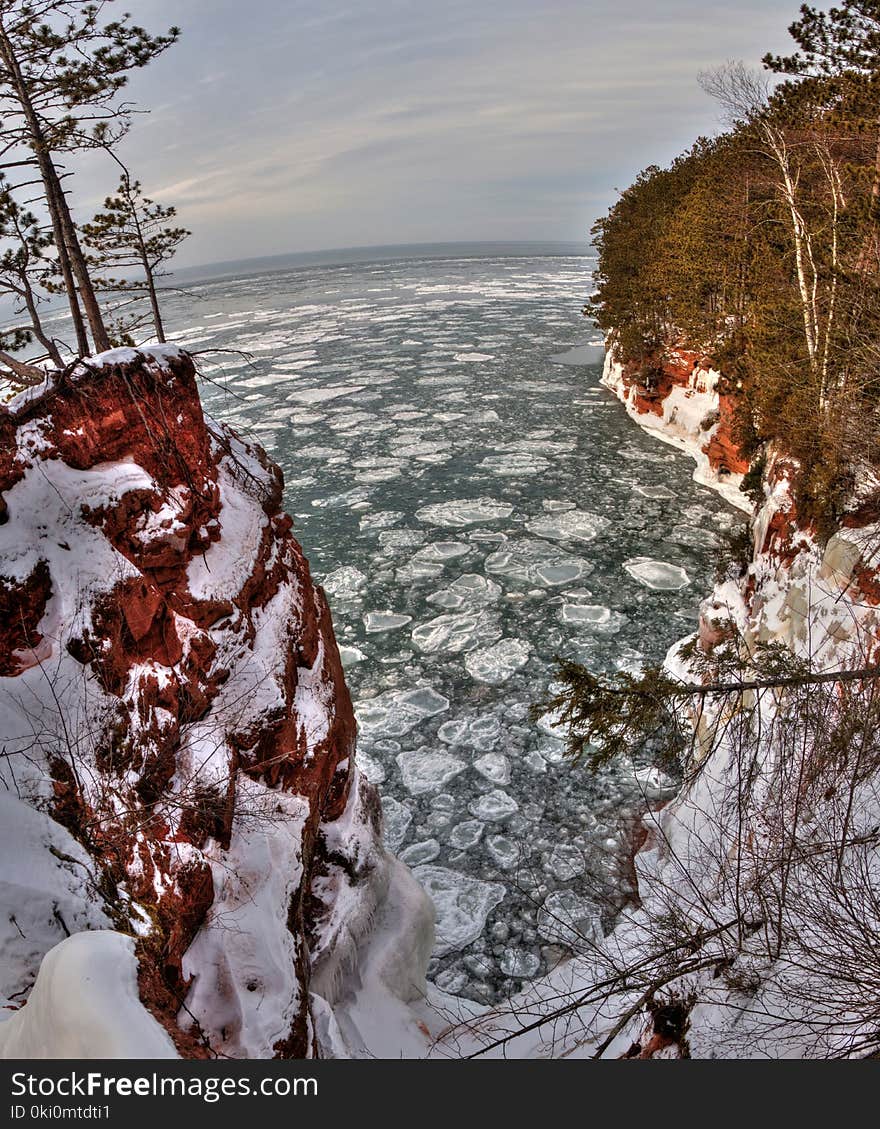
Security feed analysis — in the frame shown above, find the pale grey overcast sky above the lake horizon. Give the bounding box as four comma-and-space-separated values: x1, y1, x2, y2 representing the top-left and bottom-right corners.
80, 0, 798, 265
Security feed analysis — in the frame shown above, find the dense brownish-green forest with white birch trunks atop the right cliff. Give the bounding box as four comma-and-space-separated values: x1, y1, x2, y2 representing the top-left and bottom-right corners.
587, 0, 880, 528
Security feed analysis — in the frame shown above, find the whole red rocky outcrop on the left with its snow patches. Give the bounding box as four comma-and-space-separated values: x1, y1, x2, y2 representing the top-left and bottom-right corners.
0, 347, 430, 1057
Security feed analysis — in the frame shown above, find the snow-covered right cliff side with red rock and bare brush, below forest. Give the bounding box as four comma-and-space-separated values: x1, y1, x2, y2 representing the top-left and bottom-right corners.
447, 350, 880, 1058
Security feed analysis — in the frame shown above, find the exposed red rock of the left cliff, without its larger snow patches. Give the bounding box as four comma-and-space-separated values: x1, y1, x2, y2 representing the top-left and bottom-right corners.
0, 353, 355, 1056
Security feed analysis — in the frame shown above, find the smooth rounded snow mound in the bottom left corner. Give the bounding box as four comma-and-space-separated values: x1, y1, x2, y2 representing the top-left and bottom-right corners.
0, 929, 177, 1059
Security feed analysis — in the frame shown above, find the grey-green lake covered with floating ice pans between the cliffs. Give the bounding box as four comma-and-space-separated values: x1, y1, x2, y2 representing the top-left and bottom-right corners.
161, 256, 741, 999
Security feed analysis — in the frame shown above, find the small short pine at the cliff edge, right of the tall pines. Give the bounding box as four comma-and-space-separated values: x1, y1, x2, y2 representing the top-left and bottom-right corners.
81, 172, 190, 342
